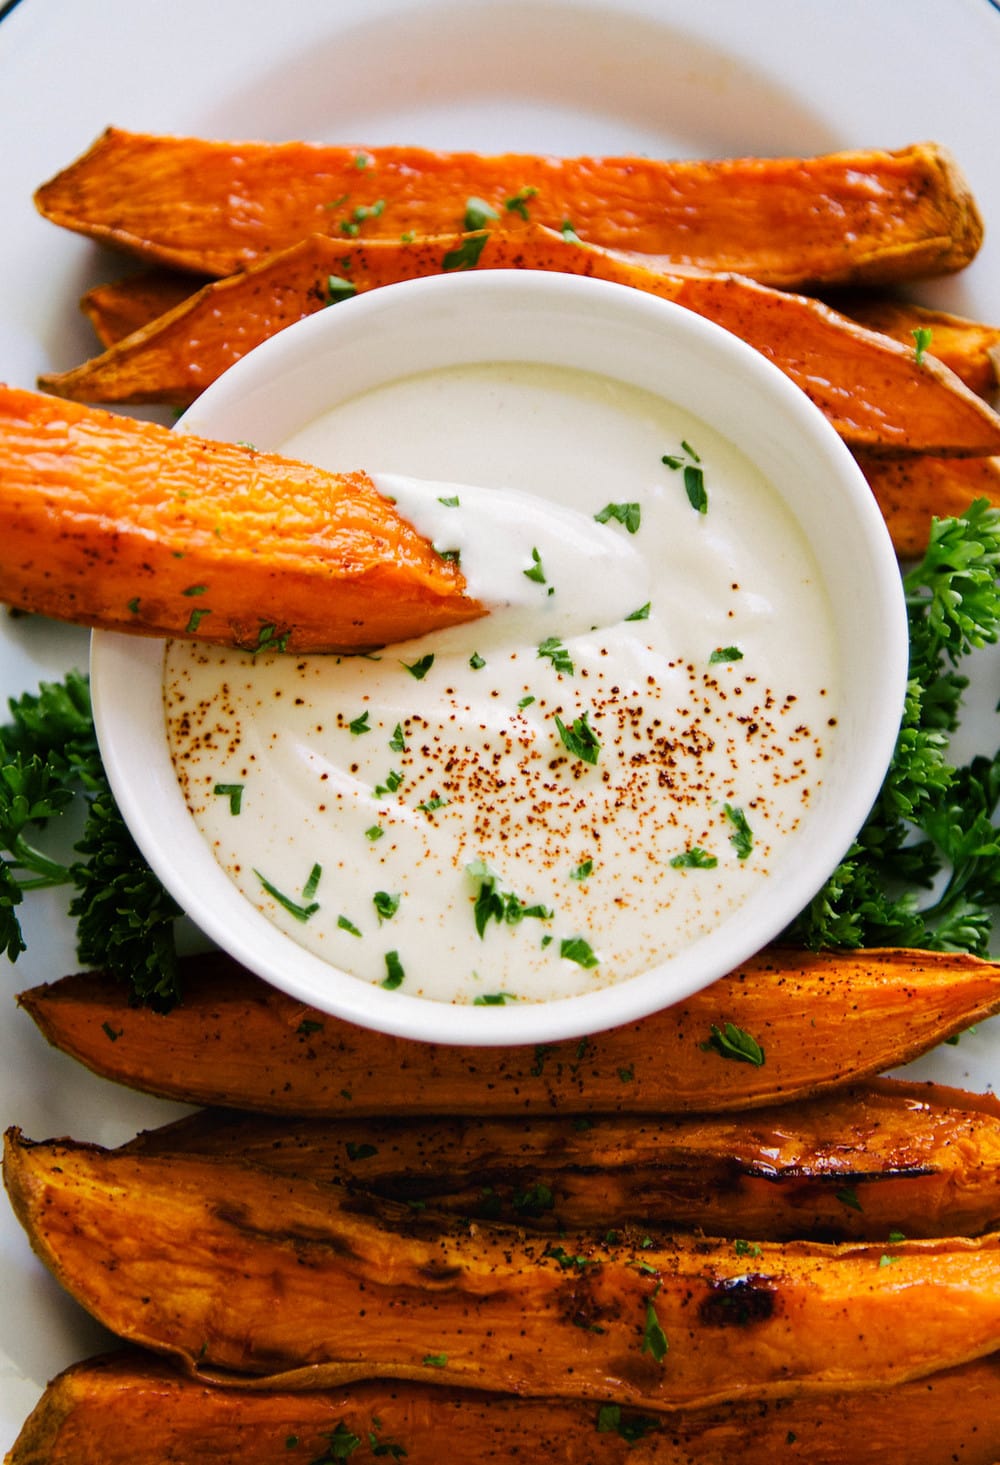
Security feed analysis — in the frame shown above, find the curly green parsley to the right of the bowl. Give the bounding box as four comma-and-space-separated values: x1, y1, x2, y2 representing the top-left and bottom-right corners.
786, 500, 1000, 957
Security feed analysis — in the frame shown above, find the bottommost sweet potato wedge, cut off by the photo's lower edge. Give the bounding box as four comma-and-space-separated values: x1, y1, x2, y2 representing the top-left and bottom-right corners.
7, 1349, 1000, 1465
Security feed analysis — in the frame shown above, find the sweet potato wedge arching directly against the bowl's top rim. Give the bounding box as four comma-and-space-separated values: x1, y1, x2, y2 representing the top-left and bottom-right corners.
40, 224, 1000, 456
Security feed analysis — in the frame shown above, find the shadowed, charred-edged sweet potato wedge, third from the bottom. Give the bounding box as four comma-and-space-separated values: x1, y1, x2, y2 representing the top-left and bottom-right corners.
123, 1080, 1000, 1241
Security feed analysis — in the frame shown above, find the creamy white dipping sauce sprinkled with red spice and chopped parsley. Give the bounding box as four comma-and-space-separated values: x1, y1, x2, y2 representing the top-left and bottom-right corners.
165, 365, 837, 1002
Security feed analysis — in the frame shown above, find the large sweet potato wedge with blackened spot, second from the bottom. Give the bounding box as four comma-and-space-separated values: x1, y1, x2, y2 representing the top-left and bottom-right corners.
4, 1131, 1000, 1411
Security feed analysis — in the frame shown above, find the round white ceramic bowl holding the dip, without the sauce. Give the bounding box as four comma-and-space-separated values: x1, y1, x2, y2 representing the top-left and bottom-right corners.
92, 271, 908, 1045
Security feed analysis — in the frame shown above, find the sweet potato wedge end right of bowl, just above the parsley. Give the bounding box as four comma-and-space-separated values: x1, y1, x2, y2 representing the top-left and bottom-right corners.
855, 453, 1000, 560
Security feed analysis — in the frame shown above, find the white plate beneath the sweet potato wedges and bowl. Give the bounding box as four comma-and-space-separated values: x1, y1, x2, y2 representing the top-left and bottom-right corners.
0, 0, 1000, 1447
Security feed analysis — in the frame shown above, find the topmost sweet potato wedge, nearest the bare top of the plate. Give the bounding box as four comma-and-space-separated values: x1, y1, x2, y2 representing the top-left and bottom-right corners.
35, 129, 982, 286
